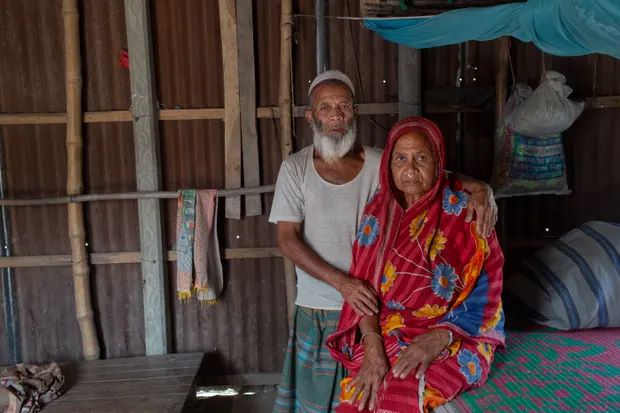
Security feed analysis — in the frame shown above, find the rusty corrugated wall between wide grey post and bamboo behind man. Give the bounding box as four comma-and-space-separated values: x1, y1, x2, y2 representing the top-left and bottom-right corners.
153, 1, 287, 372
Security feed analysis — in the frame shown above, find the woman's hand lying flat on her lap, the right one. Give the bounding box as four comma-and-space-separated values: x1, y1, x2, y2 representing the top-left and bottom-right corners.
392, 328, 450, 379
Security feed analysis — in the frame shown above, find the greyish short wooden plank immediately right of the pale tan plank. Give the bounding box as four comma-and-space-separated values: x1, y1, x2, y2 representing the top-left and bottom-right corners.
237, 0, 263, 216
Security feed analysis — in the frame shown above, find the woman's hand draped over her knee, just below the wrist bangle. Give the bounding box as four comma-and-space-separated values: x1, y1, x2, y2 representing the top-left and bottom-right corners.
346, 334, 389, 411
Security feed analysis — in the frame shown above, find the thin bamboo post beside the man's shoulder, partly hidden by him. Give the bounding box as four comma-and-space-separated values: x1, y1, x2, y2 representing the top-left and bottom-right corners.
279, 0, 297, 325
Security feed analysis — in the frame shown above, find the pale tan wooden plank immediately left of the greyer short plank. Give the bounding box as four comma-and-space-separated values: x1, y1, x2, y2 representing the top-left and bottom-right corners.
219, 0, 241, 219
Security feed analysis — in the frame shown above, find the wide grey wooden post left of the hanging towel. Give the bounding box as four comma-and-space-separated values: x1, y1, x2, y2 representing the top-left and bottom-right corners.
125, 0, 170, 355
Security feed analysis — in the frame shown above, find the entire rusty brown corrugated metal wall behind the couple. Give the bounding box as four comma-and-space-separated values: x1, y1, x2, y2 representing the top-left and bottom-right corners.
0, 0, 620, 372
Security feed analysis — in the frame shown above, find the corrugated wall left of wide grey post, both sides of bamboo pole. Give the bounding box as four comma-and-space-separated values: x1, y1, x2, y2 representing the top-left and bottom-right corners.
0, 0, 144, 363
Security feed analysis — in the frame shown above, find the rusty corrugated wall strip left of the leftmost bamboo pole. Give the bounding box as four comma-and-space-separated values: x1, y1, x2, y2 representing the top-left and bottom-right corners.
0, 1, 75, 362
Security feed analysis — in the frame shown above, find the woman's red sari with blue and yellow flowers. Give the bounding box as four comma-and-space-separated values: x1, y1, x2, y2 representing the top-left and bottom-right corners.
328, 117, 504, 412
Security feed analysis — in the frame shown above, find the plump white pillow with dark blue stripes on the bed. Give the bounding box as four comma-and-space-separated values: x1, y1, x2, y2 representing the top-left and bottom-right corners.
506, 221, 620, 330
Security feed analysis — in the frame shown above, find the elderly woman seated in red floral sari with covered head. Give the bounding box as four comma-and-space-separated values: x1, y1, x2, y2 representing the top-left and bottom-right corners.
328, 117, 504, 412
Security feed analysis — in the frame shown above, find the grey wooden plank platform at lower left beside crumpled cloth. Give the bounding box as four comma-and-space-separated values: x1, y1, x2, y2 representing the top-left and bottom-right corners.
45, 353, 203, 413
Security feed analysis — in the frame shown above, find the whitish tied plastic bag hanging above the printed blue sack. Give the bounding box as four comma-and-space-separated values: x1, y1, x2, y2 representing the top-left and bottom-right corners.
504, 70, 585, 136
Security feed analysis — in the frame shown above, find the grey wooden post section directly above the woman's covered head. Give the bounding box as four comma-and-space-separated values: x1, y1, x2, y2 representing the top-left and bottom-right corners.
398, 45, 422, 119
